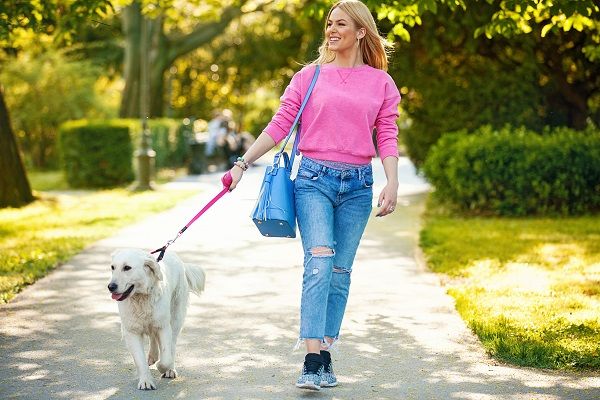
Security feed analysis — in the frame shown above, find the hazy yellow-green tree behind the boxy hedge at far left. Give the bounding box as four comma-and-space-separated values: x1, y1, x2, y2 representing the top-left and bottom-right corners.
0, 49, 104, 169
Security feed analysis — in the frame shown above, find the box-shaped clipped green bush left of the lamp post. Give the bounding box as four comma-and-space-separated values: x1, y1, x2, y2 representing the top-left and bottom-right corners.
58, 120, 133, 188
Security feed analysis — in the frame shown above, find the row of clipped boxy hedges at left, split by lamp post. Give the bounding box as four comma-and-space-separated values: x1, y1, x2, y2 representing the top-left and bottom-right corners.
58, 119, 189, 188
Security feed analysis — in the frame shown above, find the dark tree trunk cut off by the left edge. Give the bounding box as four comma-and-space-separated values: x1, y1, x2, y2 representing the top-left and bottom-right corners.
0, 86, 34, 208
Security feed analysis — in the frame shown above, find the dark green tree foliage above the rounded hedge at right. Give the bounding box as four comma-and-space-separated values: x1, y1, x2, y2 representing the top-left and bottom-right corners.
388, 2, 600, 166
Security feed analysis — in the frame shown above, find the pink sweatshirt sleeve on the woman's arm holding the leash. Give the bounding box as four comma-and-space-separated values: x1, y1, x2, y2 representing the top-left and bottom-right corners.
265, 71, 302, 144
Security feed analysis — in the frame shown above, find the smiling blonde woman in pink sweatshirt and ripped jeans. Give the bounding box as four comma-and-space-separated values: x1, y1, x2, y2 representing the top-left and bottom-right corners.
231, 0, 400, 390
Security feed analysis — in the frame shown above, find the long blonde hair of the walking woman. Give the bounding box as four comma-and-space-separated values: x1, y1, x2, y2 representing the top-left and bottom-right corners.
312, 0, 393, 71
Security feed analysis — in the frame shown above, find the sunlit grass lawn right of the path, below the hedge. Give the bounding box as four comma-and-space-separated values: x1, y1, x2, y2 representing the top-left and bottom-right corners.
420, 199, 600, 369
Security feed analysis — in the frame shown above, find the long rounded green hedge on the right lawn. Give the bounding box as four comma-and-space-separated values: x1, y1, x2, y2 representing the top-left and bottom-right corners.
423, 127, 600, 215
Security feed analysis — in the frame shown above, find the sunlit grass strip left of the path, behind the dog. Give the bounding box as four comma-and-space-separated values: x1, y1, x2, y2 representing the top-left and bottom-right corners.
0, 188, 193, 303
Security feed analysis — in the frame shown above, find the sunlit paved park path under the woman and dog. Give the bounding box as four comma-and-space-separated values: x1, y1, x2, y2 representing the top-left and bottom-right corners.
0, 160, 600, 400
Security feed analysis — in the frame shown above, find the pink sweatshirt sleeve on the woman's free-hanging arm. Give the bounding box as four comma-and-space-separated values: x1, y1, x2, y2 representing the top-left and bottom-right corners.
375, 77, 400, 161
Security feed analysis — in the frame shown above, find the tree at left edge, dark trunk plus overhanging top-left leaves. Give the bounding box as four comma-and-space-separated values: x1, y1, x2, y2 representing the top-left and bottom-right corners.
0, 0, 110, 208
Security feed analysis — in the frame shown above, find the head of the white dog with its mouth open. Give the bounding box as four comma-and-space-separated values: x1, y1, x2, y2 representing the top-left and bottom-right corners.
108, 249, 163, 301
